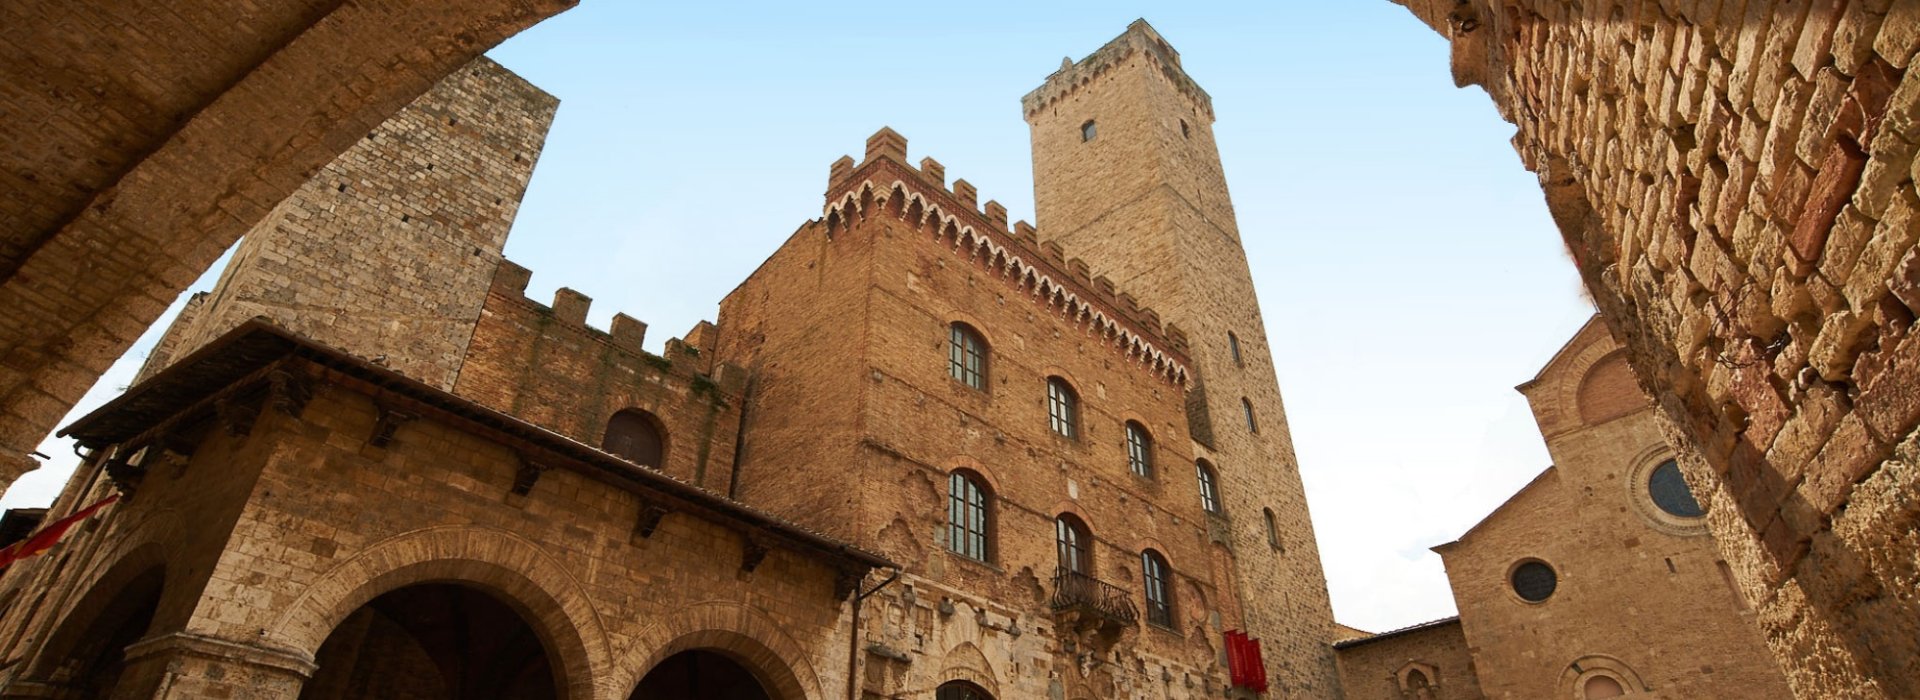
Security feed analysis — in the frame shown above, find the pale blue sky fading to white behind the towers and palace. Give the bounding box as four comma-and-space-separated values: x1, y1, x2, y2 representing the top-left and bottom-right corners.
11, 0, 1590, 631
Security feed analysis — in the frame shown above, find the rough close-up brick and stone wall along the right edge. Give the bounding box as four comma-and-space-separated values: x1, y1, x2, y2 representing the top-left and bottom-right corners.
1404, 0, 1920, 698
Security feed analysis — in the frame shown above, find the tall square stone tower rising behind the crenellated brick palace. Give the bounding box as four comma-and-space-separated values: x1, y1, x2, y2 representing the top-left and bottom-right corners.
1021, 19, 1340, 698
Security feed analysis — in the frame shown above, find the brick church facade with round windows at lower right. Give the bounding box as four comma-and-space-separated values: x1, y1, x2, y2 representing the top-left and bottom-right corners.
1436, 320, 1789, 698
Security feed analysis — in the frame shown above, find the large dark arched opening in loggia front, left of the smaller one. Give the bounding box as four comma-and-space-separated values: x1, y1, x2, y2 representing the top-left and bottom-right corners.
300, 583, 564, 700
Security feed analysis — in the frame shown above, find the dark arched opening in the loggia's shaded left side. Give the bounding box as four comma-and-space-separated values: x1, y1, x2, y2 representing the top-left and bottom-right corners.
50, 566, 167, 700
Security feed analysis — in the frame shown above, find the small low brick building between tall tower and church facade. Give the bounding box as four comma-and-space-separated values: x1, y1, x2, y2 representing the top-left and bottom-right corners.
1334, 618, 1486, 700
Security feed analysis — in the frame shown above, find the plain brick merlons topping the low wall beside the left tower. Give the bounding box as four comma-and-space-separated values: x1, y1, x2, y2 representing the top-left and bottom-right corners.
490, 259, 747, 393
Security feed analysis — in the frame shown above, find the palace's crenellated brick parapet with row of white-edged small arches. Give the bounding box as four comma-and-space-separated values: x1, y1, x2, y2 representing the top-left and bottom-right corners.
822, 127, 1188, 385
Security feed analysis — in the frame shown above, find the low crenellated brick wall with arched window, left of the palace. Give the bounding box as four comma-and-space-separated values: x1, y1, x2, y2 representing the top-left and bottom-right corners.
453, 261, 747, 493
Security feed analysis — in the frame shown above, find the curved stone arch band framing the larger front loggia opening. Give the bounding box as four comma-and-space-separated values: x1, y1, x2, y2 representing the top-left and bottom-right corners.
265, 527, 611, 700
